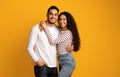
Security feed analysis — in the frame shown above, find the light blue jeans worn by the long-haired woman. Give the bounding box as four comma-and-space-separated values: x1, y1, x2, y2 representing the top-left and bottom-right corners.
58, 53, 75, 77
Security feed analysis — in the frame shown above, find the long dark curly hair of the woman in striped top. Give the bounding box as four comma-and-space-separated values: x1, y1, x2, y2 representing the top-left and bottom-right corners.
58, 12, 80, 51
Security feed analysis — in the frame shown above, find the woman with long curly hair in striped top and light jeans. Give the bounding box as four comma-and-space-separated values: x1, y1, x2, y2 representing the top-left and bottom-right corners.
42, 12, 80, 77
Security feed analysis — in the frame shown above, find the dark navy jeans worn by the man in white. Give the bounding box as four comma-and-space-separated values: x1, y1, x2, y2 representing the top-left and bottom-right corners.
34, 65, 58, 77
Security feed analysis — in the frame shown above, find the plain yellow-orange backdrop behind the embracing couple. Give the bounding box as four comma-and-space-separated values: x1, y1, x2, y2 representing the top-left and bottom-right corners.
0, 0, 120, 77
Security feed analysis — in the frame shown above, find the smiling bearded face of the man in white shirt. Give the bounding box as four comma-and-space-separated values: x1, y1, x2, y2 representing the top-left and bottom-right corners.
47, 9, 58, 24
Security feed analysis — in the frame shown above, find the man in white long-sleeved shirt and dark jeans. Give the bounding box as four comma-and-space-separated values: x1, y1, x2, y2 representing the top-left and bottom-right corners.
27, 6, 72, 77
